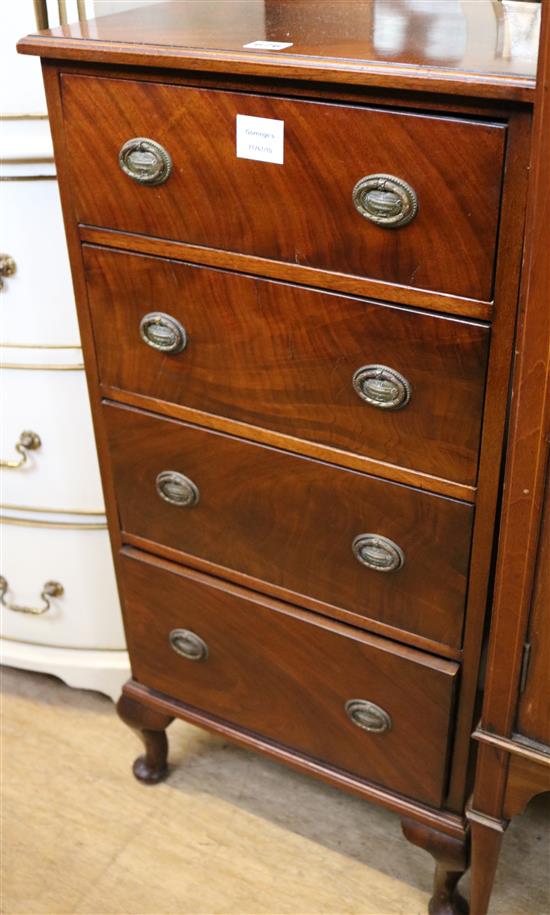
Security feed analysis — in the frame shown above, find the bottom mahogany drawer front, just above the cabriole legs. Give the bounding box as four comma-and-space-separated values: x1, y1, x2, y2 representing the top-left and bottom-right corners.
122, 553, 457, 805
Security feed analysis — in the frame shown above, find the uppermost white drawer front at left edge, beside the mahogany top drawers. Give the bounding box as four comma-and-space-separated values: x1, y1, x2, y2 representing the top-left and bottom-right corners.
0, 180, 80, 346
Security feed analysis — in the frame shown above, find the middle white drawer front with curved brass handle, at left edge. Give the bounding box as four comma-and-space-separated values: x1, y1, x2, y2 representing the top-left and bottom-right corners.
0, 362, 103, 511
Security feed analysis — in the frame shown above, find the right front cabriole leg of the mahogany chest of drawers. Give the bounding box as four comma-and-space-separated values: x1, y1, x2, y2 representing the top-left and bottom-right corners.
401, 819, 469, 915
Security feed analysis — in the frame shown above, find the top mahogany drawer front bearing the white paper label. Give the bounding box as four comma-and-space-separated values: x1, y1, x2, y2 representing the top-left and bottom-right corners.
62, 75, 506, 301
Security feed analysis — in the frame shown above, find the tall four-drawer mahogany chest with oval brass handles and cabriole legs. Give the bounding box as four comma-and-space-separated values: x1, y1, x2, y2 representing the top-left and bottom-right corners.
20, 0, 535, 913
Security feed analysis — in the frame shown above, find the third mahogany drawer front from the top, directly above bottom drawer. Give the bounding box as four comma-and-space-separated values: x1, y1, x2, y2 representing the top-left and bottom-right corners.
104, 405, 473, 647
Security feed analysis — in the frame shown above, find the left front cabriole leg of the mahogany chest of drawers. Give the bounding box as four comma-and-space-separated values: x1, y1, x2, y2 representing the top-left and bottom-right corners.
117, 693, 174, 785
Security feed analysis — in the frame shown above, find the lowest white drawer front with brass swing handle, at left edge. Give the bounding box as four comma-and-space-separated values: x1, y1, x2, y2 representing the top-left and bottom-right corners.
0, 524, 125, 649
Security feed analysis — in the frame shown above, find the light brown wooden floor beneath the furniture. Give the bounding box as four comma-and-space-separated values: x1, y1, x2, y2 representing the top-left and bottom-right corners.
2, 668, 550, 915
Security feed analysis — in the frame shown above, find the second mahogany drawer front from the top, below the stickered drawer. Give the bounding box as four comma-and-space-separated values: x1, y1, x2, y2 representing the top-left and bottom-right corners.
85, 246, 489, 484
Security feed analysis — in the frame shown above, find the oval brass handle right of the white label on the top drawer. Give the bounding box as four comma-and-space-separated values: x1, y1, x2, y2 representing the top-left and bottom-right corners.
352, 175, 418, 229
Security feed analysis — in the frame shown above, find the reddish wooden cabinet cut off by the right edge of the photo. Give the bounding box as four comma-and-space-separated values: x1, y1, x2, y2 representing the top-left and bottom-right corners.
469, 3, 550, 915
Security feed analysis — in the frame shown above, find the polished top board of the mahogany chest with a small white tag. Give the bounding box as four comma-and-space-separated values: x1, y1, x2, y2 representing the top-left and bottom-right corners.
19, 0, 539, 99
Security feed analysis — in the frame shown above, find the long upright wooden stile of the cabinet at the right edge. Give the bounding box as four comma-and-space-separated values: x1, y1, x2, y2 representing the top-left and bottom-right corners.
482, 4, 550, 752
